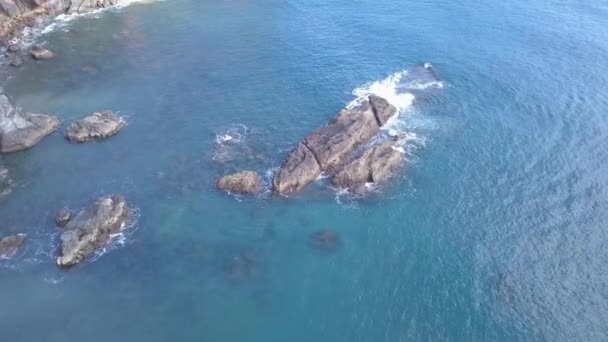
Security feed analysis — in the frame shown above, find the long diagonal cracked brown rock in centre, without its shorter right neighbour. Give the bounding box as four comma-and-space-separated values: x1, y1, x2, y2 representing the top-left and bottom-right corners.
273, 95, 397, 194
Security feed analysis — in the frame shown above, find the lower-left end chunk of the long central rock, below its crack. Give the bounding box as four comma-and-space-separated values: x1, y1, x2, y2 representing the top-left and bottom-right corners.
272, 143, 321, 194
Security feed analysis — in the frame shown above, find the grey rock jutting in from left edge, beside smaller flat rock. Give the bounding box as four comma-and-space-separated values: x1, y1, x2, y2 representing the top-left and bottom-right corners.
0, 95, 59, 153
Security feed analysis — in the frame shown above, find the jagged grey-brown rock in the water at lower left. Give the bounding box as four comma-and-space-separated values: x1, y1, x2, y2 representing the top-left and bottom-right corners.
57, 196, 131, 267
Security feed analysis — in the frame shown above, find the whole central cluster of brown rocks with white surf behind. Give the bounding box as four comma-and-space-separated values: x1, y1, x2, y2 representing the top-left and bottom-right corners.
273, 95, 402, 195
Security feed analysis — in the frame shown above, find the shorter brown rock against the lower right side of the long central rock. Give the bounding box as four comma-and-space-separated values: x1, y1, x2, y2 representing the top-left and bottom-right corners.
333, 141, 403, 194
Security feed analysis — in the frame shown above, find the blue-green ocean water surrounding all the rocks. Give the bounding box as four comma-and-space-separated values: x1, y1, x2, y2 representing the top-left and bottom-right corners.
0, 0, 608, 342
